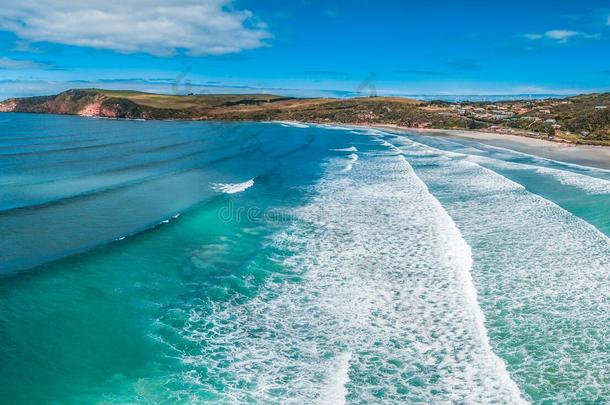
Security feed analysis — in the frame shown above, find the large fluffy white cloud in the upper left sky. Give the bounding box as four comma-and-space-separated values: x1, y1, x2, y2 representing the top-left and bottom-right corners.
0, 0, 270, 56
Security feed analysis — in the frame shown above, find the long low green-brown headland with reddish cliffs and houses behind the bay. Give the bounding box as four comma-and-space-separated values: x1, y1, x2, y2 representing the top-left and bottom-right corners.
0, 89, 610, 145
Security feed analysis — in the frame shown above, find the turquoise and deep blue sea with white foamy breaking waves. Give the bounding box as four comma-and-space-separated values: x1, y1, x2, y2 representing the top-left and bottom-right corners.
0, 114, 610, 404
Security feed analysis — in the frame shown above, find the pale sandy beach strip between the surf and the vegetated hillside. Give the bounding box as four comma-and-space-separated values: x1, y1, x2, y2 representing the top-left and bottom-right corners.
370, 125, 610, 170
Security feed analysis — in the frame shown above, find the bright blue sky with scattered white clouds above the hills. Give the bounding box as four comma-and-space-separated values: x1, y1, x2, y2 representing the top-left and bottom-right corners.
0, 0, 610, 99
